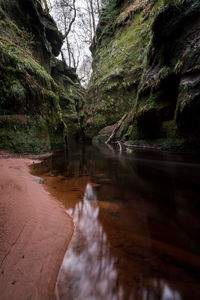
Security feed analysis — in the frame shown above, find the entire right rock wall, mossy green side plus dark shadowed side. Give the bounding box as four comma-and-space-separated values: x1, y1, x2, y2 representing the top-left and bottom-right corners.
85, 0, 200, 149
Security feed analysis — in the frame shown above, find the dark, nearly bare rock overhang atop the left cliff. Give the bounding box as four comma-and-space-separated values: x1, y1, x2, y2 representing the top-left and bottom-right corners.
2, 0, 63, 63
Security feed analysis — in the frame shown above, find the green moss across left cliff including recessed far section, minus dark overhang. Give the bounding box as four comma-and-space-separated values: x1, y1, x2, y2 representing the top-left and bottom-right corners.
0, 0, 84, 152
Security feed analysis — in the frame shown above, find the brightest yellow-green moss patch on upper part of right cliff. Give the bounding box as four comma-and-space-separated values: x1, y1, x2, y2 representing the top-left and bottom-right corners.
93, 0, 163, 83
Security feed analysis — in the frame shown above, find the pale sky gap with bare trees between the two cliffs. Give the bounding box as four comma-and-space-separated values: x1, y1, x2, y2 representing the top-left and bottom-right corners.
47, 0, 102, 82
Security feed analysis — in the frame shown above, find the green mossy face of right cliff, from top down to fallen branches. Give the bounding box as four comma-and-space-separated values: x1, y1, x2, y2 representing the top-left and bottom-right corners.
85, 0, 164, 140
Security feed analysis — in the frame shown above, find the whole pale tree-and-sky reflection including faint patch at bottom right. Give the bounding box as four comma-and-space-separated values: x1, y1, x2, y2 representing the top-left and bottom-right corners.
56, 183, 182, 300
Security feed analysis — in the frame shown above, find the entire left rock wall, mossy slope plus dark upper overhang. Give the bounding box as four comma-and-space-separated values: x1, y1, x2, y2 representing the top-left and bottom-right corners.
0, 0, 82, 152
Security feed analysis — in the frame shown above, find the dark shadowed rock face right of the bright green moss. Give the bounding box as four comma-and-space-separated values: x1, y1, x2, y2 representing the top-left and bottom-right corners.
137, 1, 200, 147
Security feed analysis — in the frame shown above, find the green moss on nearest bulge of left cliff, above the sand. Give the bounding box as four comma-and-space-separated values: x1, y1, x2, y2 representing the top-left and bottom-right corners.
0, 10, 65, 153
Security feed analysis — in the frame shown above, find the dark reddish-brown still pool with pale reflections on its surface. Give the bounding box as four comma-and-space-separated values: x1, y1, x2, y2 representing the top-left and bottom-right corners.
32, 144, 200, 300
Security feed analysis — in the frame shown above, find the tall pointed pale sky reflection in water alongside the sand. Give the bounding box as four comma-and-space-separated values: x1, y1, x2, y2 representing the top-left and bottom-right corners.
57, 183, 123, 300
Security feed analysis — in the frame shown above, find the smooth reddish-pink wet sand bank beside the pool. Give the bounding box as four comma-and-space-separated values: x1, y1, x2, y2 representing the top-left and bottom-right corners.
0, 157, 74, 300
